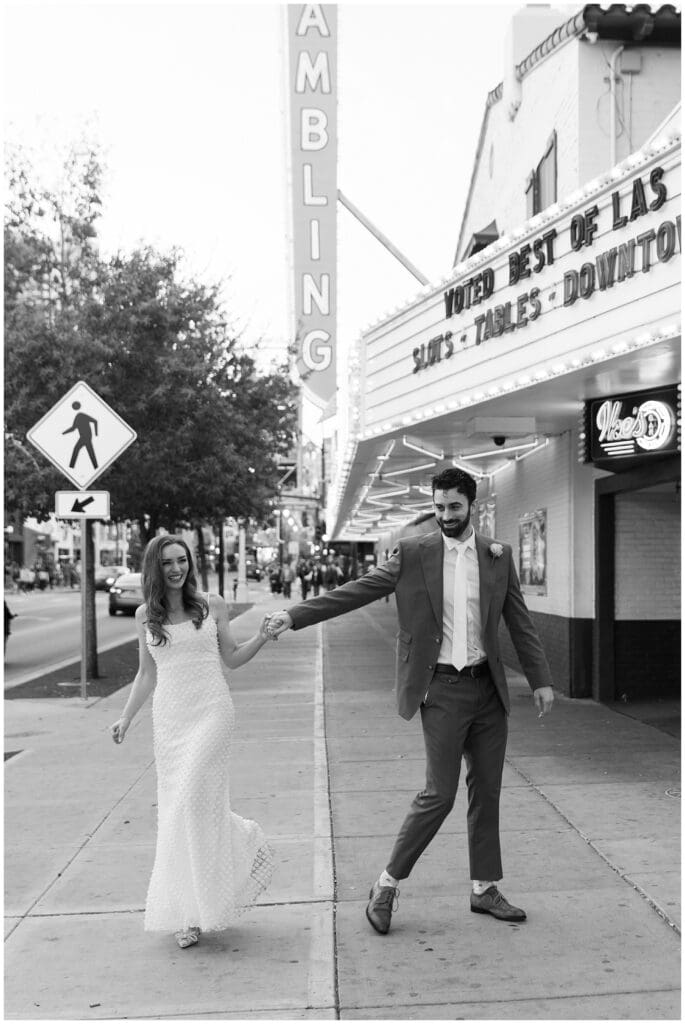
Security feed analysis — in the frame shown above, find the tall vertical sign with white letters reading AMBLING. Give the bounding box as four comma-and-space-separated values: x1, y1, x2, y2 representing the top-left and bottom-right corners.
288, 4, 338, 406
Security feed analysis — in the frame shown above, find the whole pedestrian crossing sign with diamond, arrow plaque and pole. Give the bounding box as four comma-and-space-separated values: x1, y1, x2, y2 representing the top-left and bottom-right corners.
27, 381, 136, 700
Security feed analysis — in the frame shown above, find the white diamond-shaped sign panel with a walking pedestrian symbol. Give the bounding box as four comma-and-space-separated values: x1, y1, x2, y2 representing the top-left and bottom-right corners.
27, 381, 136, 490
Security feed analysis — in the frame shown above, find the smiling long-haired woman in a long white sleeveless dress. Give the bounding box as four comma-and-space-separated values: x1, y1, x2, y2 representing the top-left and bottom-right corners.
111, 535, 272, 948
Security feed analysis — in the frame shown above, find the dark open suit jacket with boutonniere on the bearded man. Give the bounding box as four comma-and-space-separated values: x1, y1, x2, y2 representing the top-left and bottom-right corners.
288, 530, 552, 719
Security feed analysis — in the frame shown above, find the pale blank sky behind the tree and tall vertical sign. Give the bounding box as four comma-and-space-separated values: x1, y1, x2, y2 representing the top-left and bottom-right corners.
3, 0, 540, 395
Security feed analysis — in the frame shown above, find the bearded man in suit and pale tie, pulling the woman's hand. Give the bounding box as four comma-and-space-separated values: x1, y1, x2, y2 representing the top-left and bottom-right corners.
269, 469, 554, 935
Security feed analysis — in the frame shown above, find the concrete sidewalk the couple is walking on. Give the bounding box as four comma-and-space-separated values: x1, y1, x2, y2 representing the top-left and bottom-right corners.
5, 595, 680, 1020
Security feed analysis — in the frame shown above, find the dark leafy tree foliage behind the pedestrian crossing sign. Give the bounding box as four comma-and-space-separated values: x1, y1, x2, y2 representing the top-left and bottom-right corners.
4, 144, 296, 535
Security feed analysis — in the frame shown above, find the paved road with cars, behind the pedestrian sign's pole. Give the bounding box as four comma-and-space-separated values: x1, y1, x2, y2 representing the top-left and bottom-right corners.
5, 590, 134, 689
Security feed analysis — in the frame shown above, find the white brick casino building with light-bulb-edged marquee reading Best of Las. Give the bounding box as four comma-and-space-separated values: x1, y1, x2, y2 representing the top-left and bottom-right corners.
330, 4, 681, 700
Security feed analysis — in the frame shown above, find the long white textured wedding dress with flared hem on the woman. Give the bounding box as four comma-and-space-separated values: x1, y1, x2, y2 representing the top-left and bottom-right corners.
144, 614, 273, 932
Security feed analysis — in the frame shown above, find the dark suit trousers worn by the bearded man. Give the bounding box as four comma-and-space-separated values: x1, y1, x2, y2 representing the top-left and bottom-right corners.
386, 673, 508, 882
